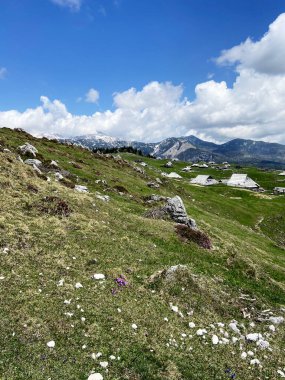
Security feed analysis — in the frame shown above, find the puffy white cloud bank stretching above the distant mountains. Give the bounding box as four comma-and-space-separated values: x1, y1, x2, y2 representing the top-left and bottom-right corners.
0, 14, 285, 144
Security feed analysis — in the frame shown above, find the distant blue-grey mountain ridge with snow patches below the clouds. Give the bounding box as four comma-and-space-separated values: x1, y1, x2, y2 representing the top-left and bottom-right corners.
60, 133, 285, 168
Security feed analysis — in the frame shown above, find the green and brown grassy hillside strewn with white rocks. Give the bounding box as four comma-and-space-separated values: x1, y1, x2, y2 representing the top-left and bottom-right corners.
0, 129, 285, 380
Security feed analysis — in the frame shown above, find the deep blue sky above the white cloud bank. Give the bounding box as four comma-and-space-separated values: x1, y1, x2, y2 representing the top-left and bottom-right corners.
0, 0, 285, 139
